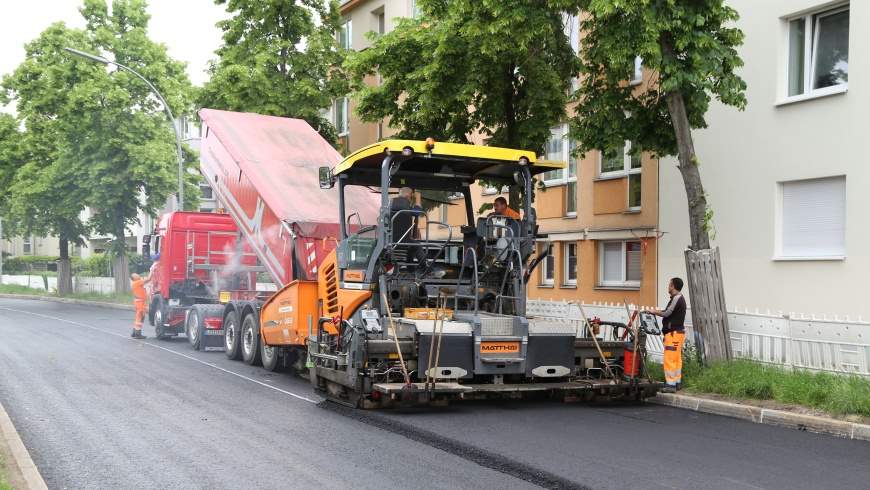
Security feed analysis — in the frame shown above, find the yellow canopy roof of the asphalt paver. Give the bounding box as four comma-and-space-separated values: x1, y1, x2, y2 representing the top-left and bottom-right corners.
335, 140, 567, 180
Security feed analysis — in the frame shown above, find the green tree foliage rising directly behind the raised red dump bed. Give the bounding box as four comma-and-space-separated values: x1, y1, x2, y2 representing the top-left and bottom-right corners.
198, 0, 347, 143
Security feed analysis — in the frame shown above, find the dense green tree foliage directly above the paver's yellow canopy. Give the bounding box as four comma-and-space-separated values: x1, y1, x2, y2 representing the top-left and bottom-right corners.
345, 0, 578, 208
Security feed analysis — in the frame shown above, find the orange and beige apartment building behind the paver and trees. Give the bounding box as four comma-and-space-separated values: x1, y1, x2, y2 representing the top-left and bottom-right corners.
331, 0, 660, 305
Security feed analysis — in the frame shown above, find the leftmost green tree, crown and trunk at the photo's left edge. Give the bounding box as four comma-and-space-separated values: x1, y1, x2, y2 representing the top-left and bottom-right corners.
0, 23, 92, 294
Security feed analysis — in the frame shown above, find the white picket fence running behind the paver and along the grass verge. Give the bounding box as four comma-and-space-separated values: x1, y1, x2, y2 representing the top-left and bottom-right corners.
527, 300, 870, 376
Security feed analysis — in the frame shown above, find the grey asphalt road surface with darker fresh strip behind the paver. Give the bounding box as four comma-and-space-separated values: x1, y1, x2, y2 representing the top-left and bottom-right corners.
0, 299, 870, 488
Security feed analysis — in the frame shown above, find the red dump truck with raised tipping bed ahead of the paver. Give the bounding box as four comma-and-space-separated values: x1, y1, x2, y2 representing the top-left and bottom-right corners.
149, 109, 379, 363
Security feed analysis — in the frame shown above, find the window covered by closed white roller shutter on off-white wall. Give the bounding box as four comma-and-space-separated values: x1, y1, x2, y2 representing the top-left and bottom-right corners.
777, 177, 846, 259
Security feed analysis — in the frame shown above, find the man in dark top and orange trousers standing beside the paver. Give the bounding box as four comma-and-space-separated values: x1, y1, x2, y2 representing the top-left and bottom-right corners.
652, 277, 686, 393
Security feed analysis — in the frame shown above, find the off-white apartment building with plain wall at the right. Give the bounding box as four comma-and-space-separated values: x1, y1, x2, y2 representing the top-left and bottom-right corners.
659, 0, 870, 319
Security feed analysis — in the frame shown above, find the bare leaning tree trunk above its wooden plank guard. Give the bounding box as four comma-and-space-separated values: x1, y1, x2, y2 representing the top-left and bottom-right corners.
667, 92, 710, 250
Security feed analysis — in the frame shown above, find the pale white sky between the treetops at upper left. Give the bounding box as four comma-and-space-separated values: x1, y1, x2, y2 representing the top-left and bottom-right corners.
0, 0, 227, 112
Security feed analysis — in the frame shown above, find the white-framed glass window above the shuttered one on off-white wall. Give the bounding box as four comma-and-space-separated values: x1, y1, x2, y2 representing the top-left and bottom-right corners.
786, 4, 849, 97
